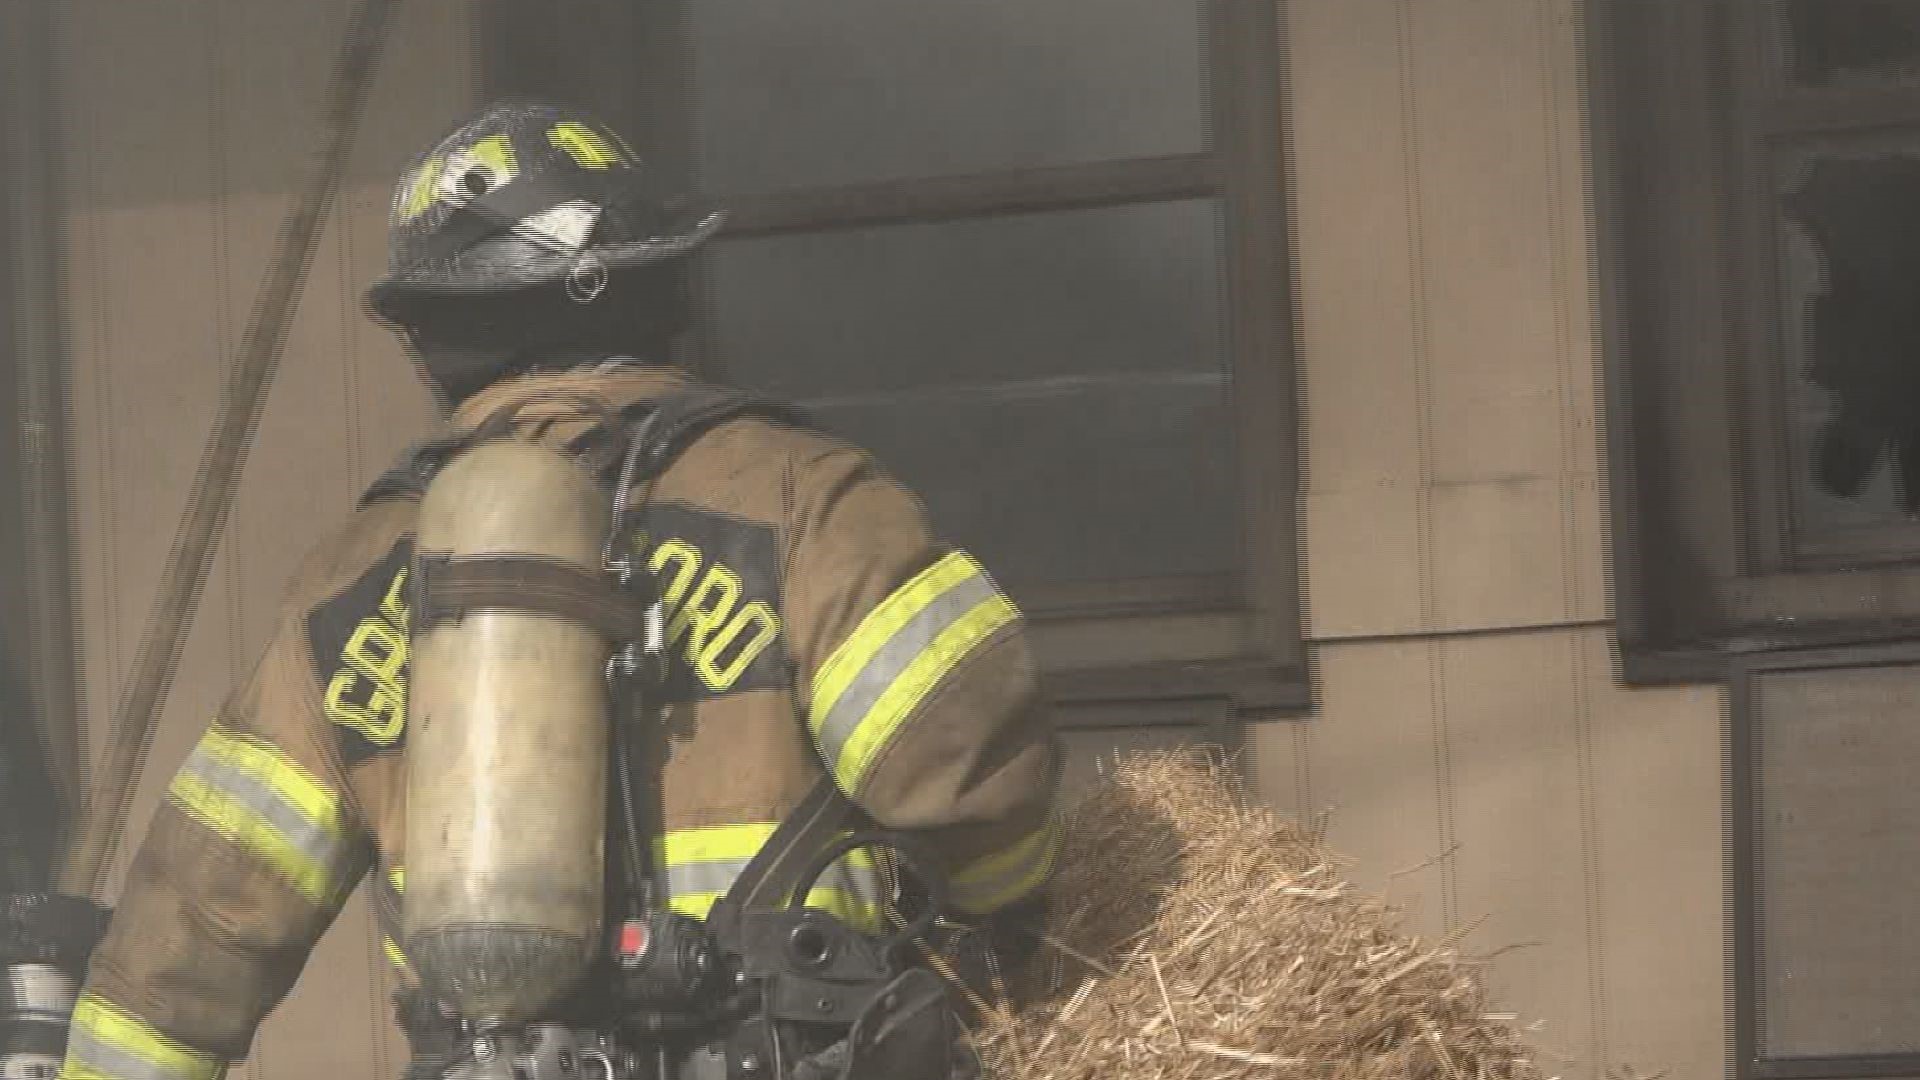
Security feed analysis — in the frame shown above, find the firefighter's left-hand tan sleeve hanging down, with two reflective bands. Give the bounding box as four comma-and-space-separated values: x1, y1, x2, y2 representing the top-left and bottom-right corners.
61, 619, 371, 1080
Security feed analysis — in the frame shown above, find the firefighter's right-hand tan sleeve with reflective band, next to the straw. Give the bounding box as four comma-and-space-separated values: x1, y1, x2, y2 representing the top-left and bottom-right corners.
785, 448, 1060, 915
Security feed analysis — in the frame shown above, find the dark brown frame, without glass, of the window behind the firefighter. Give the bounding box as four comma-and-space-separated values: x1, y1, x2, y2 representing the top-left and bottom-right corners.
482, 0, 1309, 713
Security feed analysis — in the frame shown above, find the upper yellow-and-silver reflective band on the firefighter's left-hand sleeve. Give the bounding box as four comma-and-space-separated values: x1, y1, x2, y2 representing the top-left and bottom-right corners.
167, 726, 349, 907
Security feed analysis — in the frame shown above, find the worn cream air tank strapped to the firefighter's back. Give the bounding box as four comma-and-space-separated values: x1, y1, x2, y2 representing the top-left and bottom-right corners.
403, 440, 616, 1022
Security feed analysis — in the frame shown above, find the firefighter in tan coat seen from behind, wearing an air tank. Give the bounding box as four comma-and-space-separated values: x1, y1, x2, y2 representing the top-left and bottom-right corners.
63, 104, 1060, 1080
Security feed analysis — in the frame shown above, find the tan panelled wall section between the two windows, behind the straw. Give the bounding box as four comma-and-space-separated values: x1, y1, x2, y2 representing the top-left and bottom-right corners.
1252, 0, 1724, 1078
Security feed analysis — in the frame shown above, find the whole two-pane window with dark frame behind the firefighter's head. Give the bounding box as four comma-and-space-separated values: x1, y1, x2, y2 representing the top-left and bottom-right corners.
488, 0, 1306, 709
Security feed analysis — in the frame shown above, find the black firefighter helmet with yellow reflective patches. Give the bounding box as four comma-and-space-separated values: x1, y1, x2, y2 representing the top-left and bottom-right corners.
367, 102, 722, 382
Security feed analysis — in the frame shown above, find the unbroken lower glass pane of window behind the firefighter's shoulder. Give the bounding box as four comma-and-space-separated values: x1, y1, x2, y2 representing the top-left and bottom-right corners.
710, 202, 1238, 584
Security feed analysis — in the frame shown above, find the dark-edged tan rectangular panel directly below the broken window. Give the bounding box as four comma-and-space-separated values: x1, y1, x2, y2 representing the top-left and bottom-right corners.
1730, 644, 1920, 1080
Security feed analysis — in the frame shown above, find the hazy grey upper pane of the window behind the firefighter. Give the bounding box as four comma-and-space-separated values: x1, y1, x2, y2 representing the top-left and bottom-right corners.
687, 0, 1208, 194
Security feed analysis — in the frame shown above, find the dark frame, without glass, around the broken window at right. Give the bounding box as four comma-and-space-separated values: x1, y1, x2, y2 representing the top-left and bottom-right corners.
1586, 0, 1920, 686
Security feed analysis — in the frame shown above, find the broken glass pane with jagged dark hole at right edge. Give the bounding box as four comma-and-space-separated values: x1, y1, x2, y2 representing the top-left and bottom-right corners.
1780, 138, 1920, 536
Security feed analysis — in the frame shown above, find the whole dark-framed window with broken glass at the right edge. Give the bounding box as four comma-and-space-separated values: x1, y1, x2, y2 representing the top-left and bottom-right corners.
1594, 0, 1920, 682
